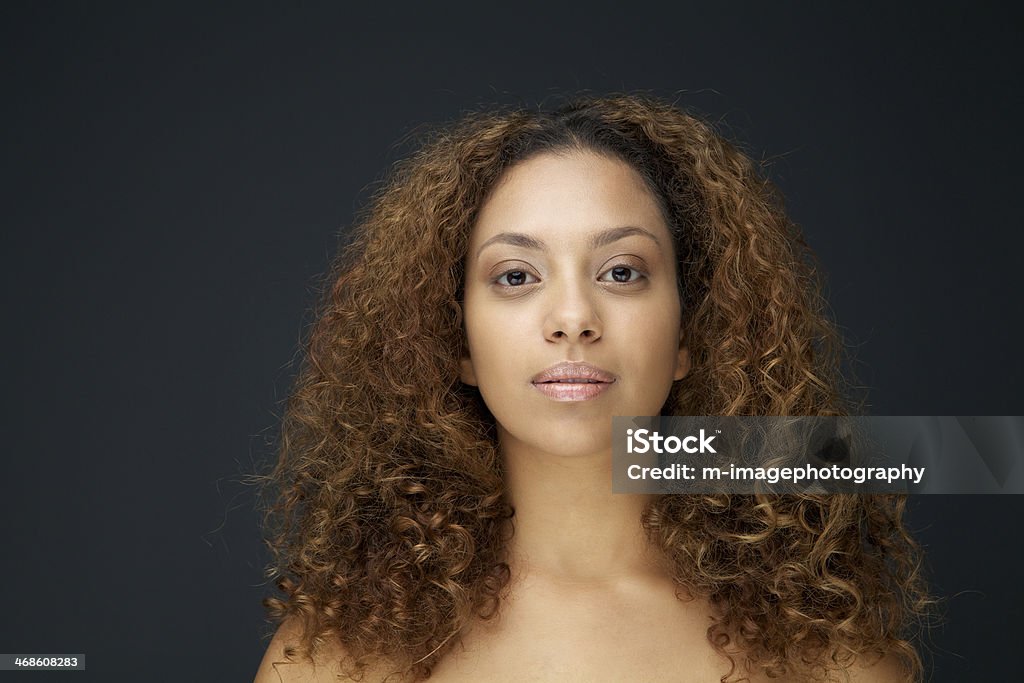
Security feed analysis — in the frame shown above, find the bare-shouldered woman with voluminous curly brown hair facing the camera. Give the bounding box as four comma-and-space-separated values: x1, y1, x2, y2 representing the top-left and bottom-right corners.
257, 96, 927, 681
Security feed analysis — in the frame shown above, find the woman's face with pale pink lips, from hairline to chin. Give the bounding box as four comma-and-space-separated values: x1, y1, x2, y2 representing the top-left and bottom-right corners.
462, 152, 689, 455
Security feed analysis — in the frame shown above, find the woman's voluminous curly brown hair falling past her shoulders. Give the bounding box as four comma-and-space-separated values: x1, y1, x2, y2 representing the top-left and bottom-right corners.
251, 94, 929, 681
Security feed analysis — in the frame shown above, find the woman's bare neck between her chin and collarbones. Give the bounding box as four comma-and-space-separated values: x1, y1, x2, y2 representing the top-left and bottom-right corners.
502, 430, 653, 582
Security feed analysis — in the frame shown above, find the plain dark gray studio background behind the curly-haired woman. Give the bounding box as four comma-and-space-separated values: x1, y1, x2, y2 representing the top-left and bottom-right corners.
0, 2, 1024, 681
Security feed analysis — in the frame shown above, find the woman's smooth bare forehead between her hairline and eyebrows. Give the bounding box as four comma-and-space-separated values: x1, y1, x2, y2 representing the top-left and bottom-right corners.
470, 151, 669, 248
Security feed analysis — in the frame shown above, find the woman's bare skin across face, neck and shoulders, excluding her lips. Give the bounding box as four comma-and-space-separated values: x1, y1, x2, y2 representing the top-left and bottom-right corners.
256, 152, 898, 683
